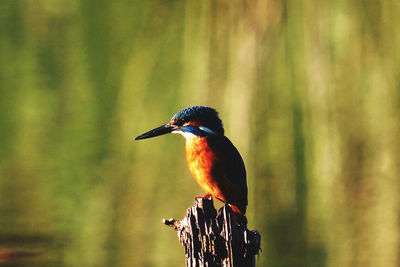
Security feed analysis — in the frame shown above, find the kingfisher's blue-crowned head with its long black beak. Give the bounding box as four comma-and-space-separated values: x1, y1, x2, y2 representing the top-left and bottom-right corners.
135, 106, 224, 140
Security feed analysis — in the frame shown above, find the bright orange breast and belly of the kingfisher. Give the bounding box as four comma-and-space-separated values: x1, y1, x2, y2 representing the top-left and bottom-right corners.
186, 136, 226, 202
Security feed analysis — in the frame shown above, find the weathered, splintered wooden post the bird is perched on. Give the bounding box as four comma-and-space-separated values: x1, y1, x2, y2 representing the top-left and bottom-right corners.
163, 197, 261, 267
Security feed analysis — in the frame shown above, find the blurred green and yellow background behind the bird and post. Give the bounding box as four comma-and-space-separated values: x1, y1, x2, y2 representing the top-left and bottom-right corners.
0, 0, 400, 267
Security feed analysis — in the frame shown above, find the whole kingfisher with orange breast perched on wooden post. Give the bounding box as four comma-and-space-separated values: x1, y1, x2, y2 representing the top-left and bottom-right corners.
135, 106, 247, 218
